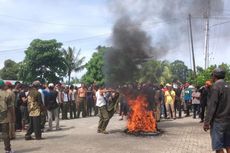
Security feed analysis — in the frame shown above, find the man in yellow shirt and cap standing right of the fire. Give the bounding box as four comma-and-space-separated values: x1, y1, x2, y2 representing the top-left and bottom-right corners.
165, 83, 176, 119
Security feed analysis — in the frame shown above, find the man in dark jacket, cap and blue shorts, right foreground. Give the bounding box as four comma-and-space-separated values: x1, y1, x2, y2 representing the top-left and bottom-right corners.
203, 68, 230, 153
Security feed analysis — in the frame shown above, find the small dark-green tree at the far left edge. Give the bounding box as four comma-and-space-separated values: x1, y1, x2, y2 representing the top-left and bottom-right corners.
0, 59, 19, 80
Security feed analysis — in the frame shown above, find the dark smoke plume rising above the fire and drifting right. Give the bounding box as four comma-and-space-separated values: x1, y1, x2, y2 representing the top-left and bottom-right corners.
104, 0, 224, 84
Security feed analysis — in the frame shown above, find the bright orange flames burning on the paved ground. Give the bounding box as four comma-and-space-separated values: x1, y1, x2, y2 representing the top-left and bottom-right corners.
127, 96, 157, 132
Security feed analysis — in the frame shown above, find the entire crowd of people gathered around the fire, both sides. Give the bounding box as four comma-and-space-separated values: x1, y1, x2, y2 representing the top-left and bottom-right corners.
0, 67, 230, 153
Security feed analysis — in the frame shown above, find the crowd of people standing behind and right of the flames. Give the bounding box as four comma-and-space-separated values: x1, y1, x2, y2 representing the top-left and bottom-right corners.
119, 80, 211, 123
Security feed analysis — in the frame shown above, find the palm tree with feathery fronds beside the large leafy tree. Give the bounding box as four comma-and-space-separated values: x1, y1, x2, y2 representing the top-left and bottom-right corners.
63, 47, 85, 84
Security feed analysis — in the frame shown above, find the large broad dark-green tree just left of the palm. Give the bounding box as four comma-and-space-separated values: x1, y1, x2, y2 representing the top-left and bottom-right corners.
20, 39, 66, 83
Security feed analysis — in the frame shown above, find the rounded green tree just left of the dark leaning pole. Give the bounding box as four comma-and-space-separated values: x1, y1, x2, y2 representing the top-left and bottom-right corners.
170, 60, 188, 82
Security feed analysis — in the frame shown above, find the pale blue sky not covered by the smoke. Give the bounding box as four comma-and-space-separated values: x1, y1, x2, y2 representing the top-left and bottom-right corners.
0, 0, 230, 78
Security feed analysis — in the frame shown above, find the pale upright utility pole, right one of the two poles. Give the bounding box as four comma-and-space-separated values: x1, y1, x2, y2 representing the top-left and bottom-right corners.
204, 1, 210, 69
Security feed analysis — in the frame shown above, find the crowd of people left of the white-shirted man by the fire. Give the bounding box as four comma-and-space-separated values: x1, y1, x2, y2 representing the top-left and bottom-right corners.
0, 80, 101, 152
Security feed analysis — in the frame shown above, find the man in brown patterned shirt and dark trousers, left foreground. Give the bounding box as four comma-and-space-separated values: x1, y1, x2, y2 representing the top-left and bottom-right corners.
25, 81, 42, 140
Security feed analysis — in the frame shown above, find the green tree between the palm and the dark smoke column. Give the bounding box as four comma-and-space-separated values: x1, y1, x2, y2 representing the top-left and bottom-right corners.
82, 46, 107, 84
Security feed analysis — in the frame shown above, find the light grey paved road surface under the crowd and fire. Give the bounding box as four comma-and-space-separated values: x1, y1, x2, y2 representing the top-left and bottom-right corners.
0, 115, 212, 153
